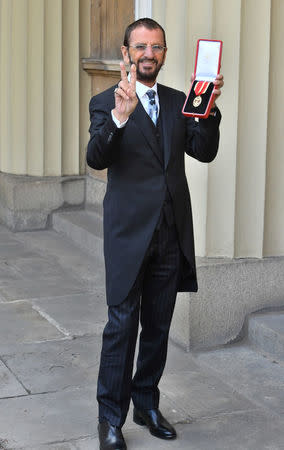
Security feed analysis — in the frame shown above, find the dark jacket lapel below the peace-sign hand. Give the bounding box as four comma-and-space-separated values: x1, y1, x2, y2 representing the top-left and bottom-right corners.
130, 99, 163, 165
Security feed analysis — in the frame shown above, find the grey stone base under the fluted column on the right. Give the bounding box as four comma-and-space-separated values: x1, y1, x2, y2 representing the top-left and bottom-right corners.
171, 257, 284, 351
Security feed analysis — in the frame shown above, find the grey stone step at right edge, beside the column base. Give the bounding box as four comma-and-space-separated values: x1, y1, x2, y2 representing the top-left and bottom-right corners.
248, 310, 284, 361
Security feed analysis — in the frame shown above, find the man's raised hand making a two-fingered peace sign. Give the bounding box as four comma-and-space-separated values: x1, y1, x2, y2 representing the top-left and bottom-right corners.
113, 62, 138, 123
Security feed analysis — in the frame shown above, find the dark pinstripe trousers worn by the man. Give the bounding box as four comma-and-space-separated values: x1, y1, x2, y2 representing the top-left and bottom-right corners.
97, 220, 182, 427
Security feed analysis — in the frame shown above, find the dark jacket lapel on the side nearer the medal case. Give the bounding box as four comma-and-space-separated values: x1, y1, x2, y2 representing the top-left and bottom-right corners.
158, 84, 174, 169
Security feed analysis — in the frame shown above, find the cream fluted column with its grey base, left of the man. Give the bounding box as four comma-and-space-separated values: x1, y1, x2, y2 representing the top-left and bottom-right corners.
0, 0, 91, 230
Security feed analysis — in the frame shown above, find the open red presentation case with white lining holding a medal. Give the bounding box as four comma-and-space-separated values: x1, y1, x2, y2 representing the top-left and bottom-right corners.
182, 39, 223, 119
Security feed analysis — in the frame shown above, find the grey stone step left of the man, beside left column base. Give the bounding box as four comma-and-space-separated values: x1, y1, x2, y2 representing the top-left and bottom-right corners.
52, 210, 103, 260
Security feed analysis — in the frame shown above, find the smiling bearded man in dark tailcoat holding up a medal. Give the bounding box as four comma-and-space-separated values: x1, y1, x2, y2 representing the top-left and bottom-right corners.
87, 19, 223, 450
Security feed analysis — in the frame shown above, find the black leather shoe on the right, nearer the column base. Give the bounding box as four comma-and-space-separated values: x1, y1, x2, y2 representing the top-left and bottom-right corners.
133, 408, 177, 439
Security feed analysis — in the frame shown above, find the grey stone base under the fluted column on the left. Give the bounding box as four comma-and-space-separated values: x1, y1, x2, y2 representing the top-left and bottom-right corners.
0, 173, 85, 231
